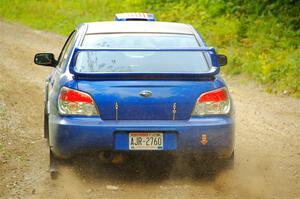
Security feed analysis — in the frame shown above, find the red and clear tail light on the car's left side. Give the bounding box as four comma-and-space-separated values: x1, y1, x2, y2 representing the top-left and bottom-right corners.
58, 87, 99, 116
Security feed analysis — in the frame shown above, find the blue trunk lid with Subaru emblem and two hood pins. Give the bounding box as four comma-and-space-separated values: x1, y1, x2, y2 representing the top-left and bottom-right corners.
77, 80, 220, 120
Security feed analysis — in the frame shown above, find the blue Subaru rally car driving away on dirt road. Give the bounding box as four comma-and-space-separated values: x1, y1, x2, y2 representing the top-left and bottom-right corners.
34, 14, 234, 178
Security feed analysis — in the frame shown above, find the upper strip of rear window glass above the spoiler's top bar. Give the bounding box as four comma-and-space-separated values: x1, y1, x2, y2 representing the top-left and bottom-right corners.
82, 33, 199, 48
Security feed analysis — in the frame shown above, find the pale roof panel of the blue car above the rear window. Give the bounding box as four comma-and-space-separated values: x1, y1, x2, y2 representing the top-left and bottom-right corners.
86, 21, 194, 34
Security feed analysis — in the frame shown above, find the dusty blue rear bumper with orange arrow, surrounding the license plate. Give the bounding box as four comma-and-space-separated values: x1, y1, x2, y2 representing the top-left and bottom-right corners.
49, 115, 234, 157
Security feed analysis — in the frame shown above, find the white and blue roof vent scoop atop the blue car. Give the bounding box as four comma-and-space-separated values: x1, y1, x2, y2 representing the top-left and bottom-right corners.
115, 12, 155, 21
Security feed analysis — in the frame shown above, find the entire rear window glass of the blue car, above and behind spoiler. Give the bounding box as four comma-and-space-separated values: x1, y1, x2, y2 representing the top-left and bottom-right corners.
74, 33, 210, 73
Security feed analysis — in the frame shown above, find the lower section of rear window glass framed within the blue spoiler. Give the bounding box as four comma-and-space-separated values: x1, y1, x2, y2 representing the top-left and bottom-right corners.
74, 50, 209, 73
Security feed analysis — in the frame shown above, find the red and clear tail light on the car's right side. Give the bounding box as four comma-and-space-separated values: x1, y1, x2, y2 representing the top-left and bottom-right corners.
192, 88, 230, 116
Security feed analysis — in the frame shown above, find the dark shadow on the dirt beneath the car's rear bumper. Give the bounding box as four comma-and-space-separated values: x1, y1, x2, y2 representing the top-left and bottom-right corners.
63, 155, 232, 183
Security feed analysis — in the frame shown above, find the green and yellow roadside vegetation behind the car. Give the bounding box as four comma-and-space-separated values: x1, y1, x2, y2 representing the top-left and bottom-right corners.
0, 0, 300, 97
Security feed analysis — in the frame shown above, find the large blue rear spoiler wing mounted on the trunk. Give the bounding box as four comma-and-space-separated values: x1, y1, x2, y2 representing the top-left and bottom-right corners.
69, 47, 220, 80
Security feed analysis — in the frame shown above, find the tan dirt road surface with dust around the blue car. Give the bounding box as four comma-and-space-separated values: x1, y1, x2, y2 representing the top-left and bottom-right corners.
0, 22, 300, 199
